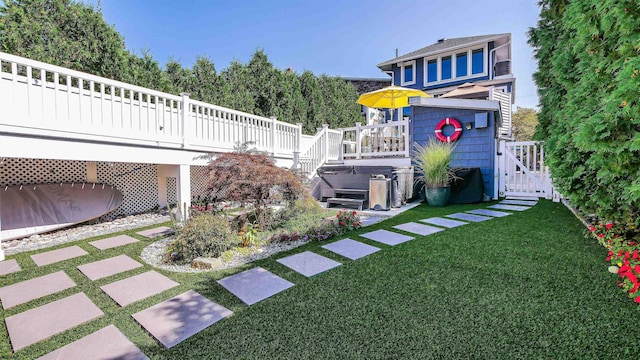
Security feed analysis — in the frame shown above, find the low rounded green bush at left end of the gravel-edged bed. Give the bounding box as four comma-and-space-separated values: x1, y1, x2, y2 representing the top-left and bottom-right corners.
167, 213, 241, 263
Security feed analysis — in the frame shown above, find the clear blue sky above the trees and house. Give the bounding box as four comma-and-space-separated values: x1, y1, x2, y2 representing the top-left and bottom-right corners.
85, 0, 539, 107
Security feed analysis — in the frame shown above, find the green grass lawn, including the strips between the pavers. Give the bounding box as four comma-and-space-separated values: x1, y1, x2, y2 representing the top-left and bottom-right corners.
0, 201, 640, 359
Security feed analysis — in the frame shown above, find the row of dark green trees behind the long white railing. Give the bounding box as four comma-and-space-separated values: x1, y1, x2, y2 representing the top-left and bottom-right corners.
0, 0, 360, 134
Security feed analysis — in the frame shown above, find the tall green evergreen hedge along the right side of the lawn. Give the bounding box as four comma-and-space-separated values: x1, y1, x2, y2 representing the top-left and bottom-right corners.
529, 0, 640, 233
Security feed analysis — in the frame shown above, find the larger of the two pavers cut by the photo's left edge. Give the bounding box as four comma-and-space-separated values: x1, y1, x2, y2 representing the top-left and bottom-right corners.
0, 271, 76, 309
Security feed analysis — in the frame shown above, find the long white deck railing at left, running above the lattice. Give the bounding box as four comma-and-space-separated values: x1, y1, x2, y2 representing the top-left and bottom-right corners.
0, 52, 302, 158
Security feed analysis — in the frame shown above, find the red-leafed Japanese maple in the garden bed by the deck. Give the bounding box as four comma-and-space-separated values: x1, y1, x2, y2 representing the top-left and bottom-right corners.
207, 152, 304, 226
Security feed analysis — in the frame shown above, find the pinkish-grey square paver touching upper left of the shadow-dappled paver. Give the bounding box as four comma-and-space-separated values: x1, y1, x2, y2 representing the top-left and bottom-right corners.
100, 271, 180, 307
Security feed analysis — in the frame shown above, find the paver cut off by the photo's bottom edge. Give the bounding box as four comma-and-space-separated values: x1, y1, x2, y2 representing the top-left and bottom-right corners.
38, 325, 149, 360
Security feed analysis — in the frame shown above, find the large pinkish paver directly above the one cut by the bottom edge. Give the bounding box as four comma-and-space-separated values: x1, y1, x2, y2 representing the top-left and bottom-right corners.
4, 293, 104, 351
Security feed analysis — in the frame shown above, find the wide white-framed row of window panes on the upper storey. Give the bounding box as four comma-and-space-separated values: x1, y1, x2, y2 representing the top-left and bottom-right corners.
424, 46, 488, 86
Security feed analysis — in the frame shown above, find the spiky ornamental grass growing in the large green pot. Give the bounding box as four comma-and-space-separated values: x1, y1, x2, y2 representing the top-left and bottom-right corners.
413, 138, 455, 187
